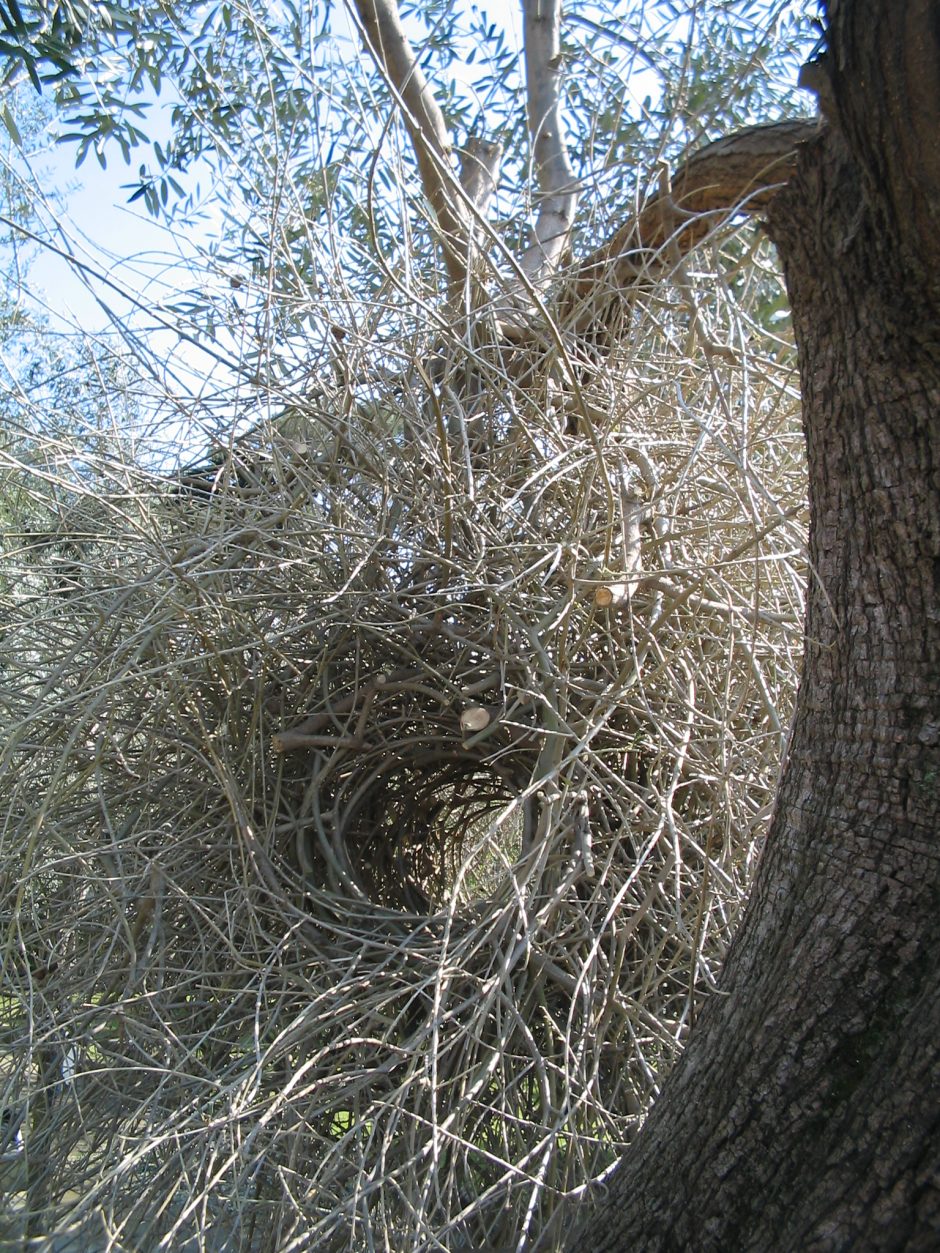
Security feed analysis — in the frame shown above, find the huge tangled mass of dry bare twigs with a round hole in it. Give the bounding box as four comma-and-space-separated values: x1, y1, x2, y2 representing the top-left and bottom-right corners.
0, 207, 803, 1253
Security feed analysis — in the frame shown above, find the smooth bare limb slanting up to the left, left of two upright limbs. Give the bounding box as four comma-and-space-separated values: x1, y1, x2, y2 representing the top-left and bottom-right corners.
356, 0, 467, 284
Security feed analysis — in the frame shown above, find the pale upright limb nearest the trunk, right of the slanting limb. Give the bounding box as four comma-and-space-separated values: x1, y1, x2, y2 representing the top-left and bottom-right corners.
521, 0, 578, 283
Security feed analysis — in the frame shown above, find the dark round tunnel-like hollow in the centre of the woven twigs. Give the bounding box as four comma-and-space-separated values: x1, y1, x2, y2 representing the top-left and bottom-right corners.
281, 675, 540, 913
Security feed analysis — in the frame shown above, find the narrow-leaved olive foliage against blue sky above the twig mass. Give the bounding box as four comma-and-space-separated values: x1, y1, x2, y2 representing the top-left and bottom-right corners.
0, 0, 811, 343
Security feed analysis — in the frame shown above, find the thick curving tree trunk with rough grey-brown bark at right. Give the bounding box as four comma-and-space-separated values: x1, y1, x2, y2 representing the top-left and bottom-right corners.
570, 0, 940, 1253
